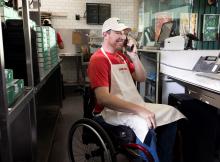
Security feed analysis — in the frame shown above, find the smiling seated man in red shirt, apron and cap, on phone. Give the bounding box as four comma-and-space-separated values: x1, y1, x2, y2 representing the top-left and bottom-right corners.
88, 18, 184, 162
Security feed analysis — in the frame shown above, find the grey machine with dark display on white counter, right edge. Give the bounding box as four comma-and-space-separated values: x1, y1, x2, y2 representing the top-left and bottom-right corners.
193, 56, 220, 73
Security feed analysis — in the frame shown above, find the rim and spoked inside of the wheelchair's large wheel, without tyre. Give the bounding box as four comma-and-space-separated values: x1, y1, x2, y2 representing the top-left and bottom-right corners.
70, 124, 112, 162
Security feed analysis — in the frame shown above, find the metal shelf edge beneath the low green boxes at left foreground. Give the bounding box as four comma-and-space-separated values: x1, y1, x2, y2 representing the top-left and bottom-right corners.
8, 87, 34, 123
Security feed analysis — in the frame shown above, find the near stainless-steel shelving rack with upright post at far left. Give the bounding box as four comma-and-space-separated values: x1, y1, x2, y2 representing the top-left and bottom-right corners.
0, 0, 37, 162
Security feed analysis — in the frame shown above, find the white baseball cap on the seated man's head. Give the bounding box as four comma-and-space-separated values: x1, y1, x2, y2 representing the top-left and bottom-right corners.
102, 17, 131, 33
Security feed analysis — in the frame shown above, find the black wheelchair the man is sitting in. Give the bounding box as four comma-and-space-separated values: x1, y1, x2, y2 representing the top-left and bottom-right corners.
68, 87, 154, 162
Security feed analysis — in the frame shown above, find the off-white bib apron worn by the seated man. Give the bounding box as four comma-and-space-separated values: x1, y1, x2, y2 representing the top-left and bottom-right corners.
101, 48, 184, 142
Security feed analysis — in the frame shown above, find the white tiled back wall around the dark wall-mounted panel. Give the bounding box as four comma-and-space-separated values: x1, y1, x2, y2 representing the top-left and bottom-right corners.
41, 0, 138, 29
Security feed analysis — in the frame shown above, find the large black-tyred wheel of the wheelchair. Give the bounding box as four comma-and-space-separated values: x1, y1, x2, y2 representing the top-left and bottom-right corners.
68, 118, 116, 162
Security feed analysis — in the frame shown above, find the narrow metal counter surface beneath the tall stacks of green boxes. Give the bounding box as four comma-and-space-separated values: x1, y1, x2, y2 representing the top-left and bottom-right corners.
35, 61, 61, 93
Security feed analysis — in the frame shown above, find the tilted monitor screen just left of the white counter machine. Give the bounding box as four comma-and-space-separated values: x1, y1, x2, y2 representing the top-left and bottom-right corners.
157, 21, 174, 44
